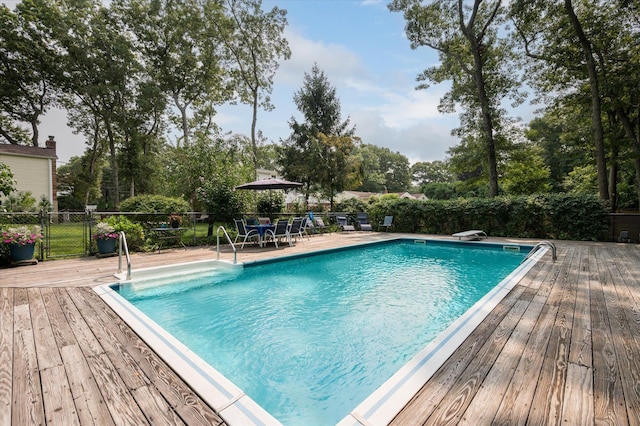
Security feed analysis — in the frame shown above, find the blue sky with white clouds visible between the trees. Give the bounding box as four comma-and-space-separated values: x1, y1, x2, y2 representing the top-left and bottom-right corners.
0, 0, 524, 164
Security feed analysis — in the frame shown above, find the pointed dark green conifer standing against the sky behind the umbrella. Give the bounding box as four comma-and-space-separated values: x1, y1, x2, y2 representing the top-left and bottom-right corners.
278, 64, 355, 207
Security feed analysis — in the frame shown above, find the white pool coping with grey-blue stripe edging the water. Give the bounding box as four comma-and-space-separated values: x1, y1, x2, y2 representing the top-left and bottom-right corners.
94, 243, 548, 426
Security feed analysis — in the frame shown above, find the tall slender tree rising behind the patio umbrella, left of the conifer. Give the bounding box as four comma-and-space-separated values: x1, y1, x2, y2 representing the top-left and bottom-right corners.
220, 0, 291, 173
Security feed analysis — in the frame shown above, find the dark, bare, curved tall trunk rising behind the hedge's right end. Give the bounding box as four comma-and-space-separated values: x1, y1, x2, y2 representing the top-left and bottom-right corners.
564, 0, 609, 200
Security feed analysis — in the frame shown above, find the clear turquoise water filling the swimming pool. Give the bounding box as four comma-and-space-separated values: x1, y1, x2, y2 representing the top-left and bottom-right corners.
120, 241, 525, 425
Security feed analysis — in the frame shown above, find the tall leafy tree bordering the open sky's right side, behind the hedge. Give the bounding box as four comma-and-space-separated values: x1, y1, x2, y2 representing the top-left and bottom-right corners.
389, 0, 522, 196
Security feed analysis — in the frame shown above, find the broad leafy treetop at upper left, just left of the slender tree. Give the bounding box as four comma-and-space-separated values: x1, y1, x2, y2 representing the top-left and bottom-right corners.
113, 0, 232, 146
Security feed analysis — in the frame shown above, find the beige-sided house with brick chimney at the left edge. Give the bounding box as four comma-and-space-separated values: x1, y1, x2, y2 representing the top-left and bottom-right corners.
0, 136, 58, 211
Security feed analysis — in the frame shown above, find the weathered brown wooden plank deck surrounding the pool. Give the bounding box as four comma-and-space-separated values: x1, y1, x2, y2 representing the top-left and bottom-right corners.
0, 233, 640, 426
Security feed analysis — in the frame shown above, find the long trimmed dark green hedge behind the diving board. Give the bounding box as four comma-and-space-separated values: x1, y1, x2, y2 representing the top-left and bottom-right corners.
368, 194, 609, 241
